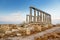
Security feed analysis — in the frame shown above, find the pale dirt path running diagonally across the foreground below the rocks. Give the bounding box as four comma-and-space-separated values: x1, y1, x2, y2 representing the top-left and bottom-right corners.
0, 27, 60, 40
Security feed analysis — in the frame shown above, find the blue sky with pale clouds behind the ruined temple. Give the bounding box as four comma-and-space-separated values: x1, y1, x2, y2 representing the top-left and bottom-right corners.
0, 0, 60, 24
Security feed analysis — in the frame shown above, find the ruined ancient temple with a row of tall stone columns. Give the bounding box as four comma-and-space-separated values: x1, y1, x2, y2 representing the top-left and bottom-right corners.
26, 7, 51, 24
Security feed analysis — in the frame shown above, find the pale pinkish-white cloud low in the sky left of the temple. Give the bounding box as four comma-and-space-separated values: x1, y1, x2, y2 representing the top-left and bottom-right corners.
0, 11, 25, 23
